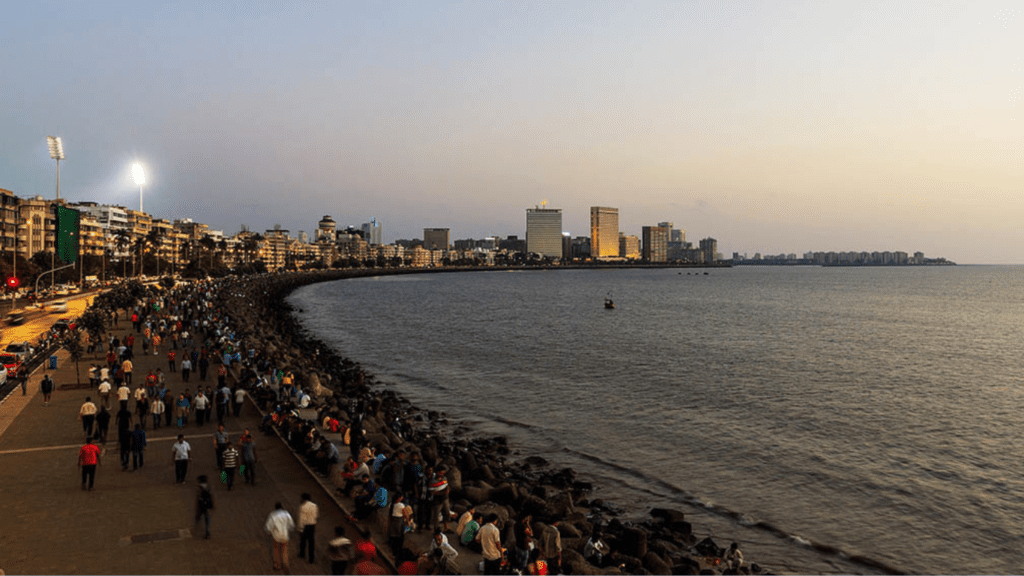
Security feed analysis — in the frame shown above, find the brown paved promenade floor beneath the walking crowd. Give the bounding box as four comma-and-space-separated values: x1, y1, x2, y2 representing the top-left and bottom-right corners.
0, 320, 385, 574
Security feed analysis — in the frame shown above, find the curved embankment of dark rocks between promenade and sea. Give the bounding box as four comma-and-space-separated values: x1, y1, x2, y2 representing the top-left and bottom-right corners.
214, 271, 760, 574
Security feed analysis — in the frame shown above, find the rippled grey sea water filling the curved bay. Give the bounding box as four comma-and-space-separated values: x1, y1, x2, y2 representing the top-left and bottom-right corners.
291, 266, 1024, 573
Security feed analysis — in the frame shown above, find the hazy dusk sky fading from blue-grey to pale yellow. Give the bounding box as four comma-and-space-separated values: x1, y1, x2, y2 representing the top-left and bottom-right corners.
0, 0, 1024, 263
